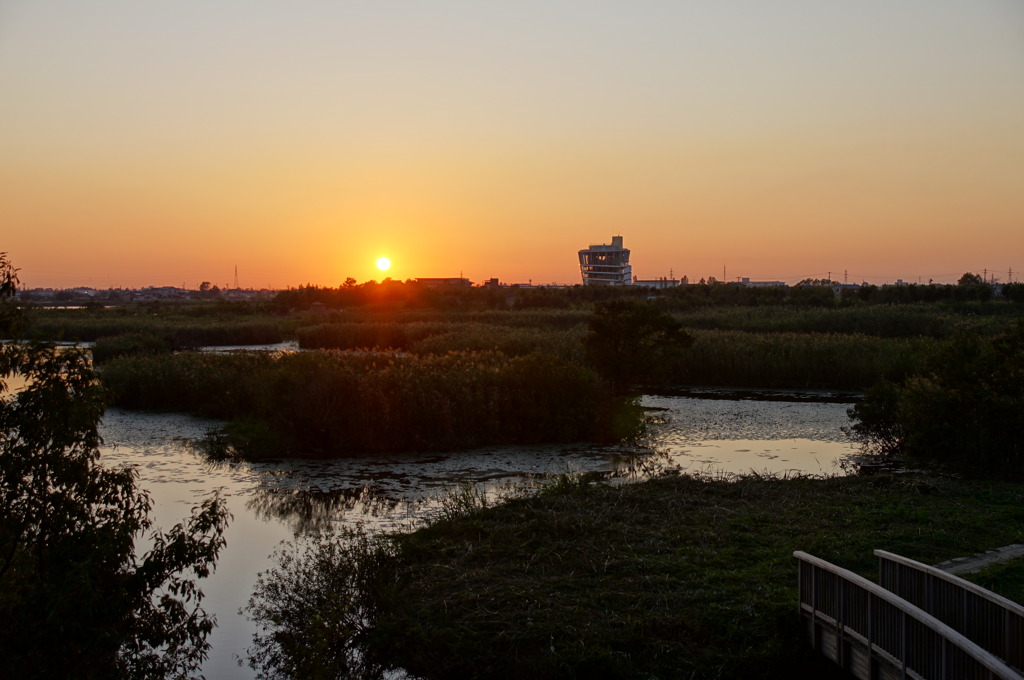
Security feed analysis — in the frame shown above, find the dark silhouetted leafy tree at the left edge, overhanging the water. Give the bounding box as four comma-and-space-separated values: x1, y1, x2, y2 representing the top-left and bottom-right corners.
0, 253, 228, 679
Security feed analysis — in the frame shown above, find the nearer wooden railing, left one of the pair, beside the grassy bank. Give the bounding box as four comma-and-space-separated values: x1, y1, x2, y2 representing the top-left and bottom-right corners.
794, 551, 1024, 680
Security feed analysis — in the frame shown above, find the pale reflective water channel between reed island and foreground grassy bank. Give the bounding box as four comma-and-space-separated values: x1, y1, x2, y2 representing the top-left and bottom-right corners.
101, 394, 856, 680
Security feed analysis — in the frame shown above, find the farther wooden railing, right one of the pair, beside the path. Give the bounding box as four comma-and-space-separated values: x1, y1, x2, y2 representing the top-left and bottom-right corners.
874, 550, 1024, 670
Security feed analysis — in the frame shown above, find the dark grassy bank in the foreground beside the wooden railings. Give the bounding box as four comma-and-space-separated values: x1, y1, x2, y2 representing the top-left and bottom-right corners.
243, 475, 1024, 679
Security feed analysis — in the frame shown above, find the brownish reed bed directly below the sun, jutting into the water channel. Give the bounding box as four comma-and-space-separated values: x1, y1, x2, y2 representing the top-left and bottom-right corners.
102, 351, 626, 456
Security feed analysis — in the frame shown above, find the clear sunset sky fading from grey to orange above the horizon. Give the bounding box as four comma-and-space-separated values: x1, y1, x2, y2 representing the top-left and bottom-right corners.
0, 0, 1024, 288
